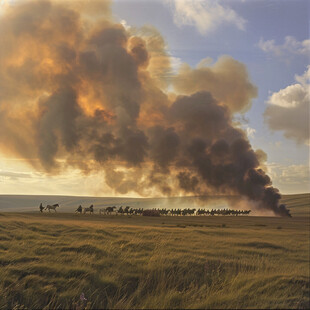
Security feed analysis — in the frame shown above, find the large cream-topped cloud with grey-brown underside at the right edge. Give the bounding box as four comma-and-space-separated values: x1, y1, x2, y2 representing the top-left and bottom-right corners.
264, 66, 310, 144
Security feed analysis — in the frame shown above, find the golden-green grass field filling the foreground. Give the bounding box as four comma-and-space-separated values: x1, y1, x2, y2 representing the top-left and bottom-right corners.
0, 194, 310, 309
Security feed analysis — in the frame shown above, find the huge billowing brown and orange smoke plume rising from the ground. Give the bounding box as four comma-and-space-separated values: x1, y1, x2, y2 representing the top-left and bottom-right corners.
0, 1, 289, 215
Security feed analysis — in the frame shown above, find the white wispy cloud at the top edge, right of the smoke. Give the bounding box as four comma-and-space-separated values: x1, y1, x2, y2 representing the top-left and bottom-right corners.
165, 0, 246, 35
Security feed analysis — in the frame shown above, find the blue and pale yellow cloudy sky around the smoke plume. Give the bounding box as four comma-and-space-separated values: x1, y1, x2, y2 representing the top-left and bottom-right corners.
0, 0, 310, 196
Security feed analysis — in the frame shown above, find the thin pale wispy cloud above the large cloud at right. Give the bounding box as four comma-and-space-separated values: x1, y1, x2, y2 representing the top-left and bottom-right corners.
258, 36, 310, 58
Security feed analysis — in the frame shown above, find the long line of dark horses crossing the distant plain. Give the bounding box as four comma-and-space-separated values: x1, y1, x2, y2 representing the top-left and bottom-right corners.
39, 203, 251, 216
